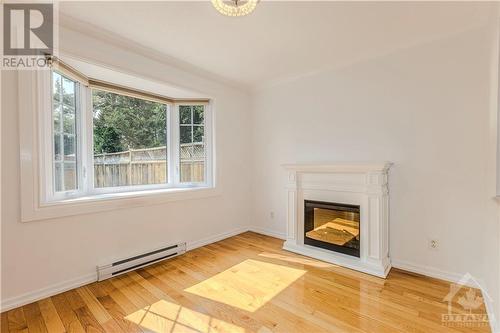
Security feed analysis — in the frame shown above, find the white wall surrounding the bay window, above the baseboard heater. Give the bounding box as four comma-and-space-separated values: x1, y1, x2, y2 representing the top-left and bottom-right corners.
1, 24, 254, 302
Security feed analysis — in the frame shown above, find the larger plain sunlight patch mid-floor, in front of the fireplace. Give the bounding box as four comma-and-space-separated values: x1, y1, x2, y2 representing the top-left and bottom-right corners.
184, 259, 306, 312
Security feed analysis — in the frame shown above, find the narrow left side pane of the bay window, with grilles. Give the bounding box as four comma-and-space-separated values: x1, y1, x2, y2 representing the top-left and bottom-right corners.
52, 72, 78, 192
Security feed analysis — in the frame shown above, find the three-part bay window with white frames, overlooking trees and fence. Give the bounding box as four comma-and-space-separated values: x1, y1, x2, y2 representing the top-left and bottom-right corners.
41, 61, 213, 203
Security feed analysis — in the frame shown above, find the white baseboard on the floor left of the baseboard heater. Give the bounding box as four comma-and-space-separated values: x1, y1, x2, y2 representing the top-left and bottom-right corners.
0, 272, 97, 312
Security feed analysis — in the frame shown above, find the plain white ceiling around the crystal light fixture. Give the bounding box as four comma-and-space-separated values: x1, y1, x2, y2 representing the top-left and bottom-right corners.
59, 0, 496, 89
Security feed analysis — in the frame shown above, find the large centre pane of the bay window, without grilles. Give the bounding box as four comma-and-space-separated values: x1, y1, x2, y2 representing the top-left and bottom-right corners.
92, 89, 168, 188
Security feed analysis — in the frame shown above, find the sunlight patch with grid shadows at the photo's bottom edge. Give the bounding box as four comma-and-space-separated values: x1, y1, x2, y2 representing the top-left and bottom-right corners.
125, 300, 245, 333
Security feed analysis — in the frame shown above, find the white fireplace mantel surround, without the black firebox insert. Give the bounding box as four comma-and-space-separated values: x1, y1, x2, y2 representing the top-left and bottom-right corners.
283, 162, 391, 278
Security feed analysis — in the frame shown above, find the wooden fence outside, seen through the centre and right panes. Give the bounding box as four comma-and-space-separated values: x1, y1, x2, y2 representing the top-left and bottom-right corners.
94, 143, 205, 187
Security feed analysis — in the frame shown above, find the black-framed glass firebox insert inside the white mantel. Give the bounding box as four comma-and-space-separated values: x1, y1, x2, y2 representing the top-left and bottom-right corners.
304, 200, 360, 258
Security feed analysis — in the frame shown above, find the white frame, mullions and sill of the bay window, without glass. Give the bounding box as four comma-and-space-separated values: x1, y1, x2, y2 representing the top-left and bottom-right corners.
18, 70, 220, 221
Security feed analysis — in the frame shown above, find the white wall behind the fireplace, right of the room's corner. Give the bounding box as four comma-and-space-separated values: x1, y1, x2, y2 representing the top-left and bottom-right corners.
252, 27, 499, 322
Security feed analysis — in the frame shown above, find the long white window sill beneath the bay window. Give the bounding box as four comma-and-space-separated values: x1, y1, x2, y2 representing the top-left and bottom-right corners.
21, 187, 220, 222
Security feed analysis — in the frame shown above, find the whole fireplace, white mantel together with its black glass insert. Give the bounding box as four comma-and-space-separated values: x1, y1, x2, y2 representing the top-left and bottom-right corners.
283, 162, 391, 278
